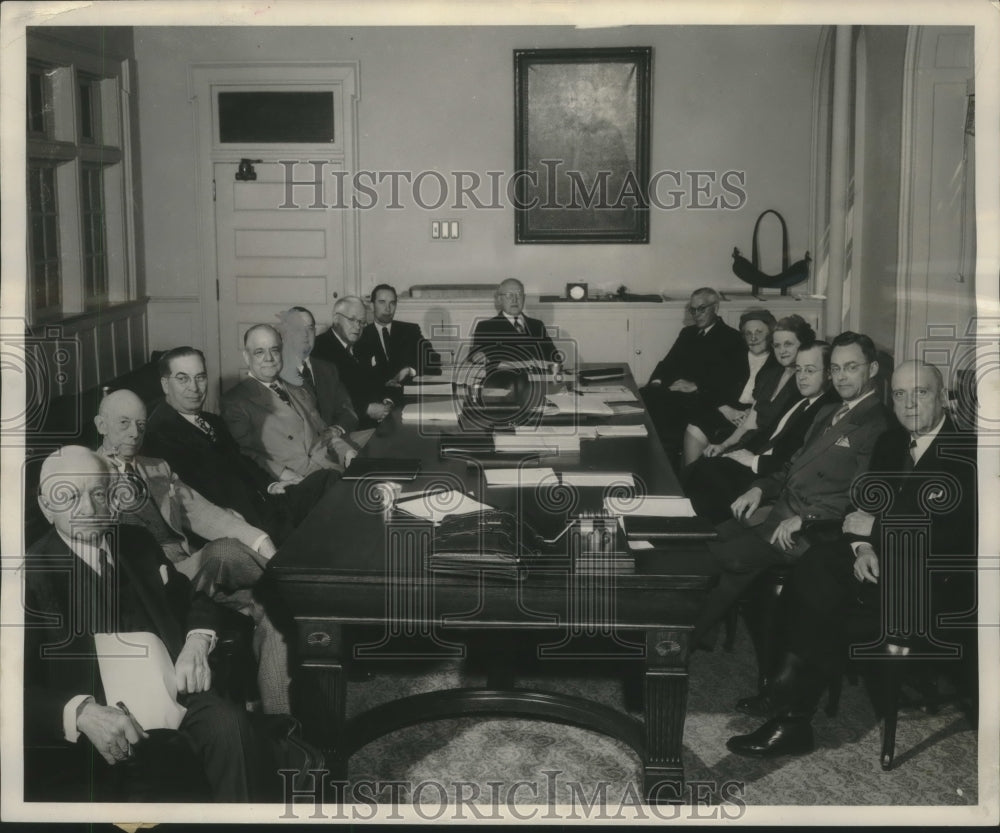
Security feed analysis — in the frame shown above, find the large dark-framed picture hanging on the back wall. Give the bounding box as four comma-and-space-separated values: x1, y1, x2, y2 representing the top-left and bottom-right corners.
514, 47, 653, 243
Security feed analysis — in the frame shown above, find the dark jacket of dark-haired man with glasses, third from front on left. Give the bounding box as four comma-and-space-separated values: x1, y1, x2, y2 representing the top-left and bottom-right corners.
143, 402, 274, 525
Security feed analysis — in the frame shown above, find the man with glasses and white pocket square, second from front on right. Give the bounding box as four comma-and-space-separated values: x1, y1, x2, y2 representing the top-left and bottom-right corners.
694, 331, 889, 642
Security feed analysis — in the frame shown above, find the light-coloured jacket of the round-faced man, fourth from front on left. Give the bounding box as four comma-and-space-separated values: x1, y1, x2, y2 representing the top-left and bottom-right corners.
222, 376, 341, 479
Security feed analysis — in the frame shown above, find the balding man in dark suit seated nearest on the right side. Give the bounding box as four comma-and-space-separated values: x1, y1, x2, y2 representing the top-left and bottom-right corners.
727, 362, 977, 757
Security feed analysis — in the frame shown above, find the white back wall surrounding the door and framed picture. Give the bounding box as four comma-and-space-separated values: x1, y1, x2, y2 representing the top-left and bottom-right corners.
134, 26, 819, 347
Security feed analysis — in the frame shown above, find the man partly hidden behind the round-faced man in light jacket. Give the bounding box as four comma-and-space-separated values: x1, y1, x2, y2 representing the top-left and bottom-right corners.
278, 307, 358, 436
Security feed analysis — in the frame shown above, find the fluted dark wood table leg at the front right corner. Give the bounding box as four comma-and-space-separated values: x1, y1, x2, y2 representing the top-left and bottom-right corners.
643, 630, 690, 804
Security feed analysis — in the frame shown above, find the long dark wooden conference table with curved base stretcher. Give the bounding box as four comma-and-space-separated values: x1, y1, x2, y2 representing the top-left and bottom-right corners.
267, 368, 714, 802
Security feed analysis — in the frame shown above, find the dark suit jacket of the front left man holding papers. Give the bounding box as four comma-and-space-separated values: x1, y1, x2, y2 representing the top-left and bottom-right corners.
24, 526, 218, 745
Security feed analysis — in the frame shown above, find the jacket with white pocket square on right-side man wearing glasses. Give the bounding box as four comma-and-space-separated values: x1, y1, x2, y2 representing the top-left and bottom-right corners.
754, 394, 891, 527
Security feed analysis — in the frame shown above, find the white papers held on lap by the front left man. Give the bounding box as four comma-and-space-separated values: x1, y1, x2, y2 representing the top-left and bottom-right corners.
94, 631, 187, 729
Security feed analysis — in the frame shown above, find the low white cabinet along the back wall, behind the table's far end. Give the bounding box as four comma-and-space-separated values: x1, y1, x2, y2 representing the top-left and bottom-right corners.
397, 296, 823, 385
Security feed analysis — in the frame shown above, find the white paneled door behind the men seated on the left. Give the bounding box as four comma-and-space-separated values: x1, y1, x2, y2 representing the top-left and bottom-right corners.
214, 161, 351, 390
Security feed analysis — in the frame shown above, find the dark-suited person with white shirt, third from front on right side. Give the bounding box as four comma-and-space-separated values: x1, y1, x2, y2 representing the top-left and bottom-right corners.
683, 341, 840, 523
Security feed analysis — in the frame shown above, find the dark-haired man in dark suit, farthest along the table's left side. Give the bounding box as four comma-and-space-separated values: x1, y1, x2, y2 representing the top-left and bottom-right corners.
356, 283, 441, 385
